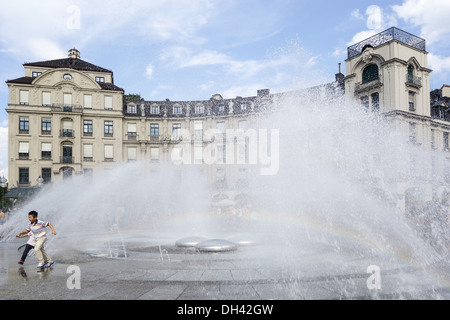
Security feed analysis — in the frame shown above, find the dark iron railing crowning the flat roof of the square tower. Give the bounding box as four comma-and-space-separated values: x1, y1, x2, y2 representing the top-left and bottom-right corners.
347, 27, 426, 59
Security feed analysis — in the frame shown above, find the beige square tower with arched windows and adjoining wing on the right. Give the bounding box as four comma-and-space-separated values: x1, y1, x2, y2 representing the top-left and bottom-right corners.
344, 28, 450, 212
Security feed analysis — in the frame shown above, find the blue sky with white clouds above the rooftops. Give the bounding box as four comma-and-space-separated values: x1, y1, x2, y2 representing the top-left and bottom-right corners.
0, 0, 450, 177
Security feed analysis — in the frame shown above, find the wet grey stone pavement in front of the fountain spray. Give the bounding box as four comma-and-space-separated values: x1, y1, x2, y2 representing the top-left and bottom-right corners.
0, 232, 450, 301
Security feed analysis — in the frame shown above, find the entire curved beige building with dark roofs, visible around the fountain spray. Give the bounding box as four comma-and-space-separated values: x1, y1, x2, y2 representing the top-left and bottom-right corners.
6, 28, 450, 209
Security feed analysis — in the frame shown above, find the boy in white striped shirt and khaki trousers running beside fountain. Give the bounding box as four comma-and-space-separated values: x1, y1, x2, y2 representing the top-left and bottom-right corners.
16, 210, 56, 268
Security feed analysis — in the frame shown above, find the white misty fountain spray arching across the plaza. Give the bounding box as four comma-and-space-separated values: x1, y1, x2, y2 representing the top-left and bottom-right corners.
3, 82, 450, 297
